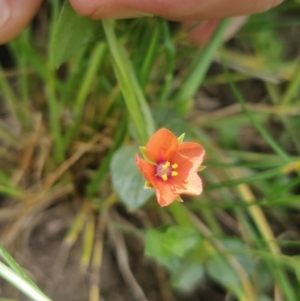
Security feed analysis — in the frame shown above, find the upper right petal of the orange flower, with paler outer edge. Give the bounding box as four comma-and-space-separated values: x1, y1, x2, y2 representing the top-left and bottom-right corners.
174, 142, 205, 173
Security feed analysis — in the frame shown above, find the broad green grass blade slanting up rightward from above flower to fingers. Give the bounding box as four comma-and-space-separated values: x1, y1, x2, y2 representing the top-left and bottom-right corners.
176, 19, 230, 114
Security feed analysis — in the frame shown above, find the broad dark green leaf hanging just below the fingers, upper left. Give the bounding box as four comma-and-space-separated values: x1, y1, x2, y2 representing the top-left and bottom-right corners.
51, 1, 101, 68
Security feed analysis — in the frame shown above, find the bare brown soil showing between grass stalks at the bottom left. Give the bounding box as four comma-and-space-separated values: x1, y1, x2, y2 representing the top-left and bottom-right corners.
0, 203, 225, 301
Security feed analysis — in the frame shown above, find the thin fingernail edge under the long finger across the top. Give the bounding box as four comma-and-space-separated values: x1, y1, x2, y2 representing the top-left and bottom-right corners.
91, 7, 153, 19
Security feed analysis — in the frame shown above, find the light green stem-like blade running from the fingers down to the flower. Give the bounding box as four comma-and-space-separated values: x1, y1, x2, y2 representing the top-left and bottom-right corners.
102, 20, 154, 144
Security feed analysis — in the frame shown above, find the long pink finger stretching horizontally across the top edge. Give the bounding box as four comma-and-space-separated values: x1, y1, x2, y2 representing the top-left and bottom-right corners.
70, 0, 283, 21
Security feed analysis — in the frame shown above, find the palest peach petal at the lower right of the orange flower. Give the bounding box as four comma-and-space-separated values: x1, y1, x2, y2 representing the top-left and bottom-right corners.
170, 172, 202, 195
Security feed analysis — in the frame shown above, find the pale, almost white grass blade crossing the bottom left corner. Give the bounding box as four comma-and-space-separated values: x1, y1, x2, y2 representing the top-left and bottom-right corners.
0, 262, 51, 301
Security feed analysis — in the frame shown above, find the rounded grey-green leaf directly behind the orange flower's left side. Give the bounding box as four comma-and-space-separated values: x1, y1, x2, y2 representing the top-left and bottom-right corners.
110, 146, 153, 209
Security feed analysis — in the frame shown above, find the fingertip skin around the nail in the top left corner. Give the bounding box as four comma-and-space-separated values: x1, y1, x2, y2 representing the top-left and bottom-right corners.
0, 0, 42, 44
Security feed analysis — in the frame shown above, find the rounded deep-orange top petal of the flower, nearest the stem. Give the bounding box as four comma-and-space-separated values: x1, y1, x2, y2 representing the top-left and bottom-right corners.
146, 128, 178, 163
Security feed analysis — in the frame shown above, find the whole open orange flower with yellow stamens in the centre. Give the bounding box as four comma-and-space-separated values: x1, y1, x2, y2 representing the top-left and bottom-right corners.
135, 128, 205, 206
